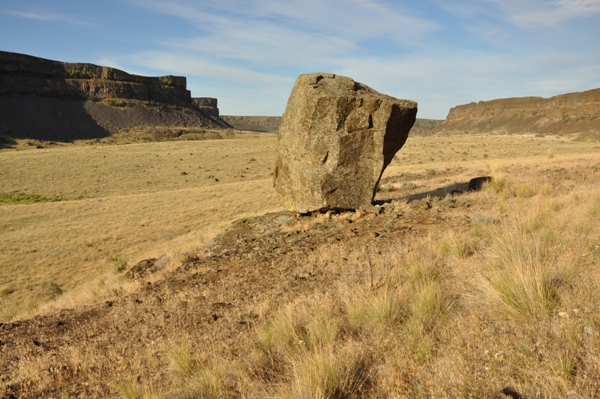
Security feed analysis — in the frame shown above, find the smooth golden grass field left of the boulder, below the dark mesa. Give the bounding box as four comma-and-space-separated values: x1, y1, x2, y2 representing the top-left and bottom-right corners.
0, 133, 278, 321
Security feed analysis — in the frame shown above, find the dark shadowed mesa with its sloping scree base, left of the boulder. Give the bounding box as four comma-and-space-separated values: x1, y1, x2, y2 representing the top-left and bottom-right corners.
0, 51, 230, 141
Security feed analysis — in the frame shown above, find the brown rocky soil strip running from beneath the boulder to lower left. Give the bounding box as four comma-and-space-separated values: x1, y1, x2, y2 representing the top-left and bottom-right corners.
0, 183, 478, 398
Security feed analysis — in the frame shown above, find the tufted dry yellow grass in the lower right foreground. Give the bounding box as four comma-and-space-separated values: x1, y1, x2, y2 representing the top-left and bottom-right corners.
122, 173, 600, 398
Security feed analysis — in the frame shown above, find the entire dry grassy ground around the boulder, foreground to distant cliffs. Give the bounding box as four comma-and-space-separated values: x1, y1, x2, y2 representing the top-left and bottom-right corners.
0, 130, 600, 398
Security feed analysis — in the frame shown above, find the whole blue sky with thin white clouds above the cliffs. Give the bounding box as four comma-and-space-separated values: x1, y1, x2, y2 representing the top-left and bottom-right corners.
0, 0, 600, 119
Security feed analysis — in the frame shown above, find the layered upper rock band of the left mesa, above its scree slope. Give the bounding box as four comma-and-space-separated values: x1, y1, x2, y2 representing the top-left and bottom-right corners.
0, 51, 192, 106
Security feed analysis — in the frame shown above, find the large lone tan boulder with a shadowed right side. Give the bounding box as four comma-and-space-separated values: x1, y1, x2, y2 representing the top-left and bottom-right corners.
273, 73, 417, 213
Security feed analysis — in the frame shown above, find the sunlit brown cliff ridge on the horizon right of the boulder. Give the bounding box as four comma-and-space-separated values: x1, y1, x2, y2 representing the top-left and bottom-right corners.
438, 89, 600, 133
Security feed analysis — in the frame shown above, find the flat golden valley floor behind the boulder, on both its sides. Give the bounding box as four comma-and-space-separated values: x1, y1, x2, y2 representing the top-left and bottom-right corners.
0, 133, 600, 320
